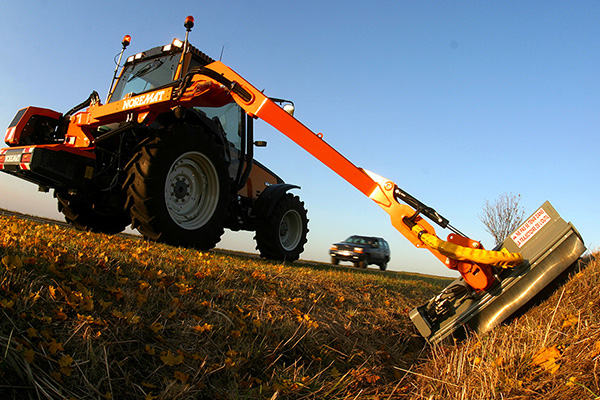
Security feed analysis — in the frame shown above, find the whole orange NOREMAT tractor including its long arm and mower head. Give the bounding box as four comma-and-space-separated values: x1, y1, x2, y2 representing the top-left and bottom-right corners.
0, 17, 585, 341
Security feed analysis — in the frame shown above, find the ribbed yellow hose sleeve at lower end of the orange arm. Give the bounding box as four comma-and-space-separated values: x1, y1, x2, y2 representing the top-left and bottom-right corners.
412, 225, 523, 268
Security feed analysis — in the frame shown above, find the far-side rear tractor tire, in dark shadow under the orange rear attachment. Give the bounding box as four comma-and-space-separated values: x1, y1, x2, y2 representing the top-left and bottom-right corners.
54, 191, 131, 235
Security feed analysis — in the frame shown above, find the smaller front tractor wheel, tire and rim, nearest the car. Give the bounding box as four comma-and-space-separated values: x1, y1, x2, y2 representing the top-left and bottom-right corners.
255, 193, 308, 261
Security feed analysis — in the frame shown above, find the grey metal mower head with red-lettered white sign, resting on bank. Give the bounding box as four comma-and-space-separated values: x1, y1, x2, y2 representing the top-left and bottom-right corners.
410, 202, 586, 343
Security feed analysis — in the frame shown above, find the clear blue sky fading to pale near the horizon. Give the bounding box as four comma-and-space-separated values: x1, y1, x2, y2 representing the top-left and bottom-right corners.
0, 0, 600, 276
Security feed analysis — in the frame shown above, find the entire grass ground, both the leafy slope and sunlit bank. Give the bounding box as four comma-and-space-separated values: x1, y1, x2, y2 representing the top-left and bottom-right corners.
0, 217, 600, 399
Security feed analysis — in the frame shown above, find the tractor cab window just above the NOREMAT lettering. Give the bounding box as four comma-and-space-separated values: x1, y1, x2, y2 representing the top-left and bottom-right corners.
110, 54, 180, 102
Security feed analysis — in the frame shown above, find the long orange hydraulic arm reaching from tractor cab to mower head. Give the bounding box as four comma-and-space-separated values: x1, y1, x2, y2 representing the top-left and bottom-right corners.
190, 61, 523, 290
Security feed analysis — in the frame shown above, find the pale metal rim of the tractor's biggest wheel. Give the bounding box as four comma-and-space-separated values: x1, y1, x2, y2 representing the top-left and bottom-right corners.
165, 151, 220, 230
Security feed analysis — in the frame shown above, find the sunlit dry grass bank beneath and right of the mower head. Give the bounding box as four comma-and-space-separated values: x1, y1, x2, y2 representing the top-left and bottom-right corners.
407, 253, 600, 400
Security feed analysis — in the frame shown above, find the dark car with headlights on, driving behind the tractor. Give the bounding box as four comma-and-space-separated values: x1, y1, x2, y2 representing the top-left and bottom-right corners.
329, 235, 390, 271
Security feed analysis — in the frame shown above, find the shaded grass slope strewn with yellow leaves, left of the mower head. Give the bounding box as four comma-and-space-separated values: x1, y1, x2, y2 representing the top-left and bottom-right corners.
0, 217, 447, 399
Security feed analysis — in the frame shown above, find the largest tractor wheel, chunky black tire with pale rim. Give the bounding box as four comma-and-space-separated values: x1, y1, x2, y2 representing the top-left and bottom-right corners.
127, 125, 231, 250
